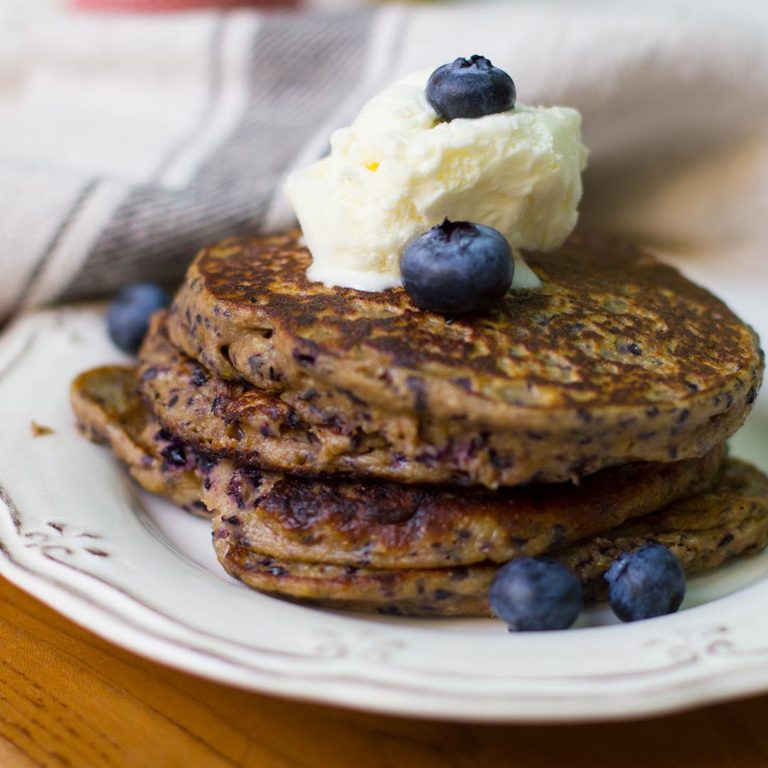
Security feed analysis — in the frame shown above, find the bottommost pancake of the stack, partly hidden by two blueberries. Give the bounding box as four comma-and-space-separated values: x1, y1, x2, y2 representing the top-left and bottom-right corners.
213, 460, 768, 616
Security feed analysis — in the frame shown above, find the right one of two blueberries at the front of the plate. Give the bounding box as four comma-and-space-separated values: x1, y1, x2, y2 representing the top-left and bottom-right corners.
605, 544, 685, 621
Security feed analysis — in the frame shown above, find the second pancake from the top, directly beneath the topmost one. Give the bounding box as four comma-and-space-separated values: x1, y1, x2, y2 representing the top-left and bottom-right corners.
144, 313, 732, 487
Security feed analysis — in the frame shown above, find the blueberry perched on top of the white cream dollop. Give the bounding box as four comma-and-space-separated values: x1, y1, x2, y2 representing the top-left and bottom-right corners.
426, 55, 517, 122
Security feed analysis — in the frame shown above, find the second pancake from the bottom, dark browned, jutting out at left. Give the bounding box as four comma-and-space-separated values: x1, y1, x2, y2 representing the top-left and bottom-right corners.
74, 368, 725, 568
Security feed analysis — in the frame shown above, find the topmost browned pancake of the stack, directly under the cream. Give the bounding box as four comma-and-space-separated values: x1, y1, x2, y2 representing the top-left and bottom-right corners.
164, 233, 763, 487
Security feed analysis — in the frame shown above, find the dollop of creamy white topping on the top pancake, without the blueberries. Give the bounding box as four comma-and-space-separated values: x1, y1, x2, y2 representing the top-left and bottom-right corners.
285, 70, 586, 291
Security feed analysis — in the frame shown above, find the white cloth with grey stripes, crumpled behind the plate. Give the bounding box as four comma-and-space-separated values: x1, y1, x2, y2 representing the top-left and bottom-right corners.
0, 3, 768, 333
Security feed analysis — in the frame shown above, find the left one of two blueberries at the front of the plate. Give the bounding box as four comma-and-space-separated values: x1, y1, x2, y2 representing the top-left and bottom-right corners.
489, 557, 582, 632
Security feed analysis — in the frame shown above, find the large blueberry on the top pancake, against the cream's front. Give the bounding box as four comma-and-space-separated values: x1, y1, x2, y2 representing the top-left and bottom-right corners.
400, 219, 515, 315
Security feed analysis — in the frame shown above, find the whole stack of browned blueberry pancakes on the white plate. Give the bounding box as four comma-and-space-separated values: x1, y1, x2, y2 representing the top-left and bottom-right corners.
72, 233, 768, 616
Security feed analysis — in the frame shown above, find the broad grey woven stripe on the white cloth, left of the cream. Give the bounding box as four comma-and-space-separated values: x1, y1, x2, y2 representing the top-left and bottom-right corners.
63, 13, 370, 299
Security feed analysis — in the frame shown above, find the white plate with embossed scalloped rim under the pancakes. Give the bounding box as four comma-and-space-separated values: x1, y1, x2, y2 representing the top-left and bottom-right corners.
0, 308, 768, 721
